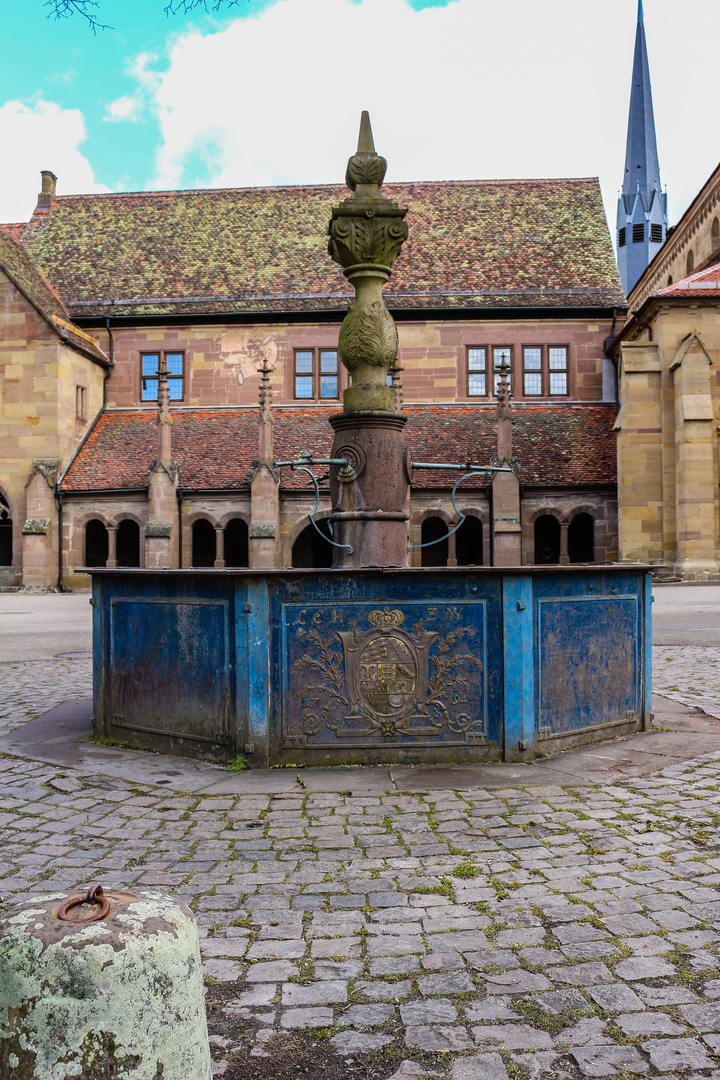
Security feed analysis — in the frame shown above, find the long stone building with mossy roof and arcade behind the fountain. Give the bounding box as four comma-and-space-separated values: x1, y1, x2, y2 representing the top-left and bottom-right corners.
0, 173, 625, 588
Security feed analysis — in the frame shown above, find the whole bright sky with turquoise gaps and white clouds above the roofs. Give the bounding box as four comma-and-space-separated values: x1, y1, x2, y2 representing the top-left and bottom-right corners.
0, 0, 720, 233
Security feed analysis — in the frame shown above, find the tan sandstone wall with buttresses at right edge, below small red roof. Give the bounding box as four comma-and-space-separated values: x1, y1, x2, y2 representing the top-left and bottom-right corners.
617, 301, 720, 580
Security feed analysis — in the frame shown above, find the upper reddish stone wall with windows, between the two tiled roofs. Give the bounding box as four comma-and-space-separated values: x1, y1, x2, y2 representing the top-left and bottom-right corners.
94, 319, 612, 408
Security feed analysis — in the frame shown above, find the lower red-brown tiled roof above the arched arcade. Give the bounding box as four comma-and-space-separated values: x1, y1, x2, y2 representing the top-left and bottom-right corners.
62, 405, 617, 491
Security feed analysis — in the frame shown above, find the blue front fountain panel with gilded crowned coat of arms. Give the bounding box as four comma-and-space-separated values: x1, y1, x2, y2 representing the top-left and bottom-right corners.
283, 600, 487, 750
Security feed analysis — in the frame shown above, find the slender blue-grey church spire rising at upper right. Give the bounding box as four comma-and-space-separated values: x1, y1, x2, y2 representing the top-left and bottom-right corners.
617, 0, 667, 295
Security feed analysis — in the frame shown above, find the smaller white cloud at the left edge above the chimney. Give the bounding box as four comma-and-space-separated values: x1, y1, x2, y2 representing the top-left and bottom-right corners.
0, 100, 108, 221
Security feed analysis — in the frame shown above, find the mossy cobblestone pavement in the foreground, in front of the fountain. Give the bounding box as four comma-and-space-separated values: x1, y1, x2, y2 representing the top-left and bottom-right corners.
0, 754, 720, 1080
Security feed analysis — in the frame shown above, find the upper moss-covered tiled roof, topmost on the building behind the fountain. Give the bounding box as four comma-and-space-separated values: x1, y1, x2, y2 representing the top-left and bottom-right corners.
15, 178, 625, 318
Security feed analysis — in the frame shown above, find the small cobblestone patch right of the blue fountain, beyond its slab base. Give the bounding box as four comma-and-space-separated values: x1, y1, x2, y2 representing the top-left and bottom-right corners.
652, 645, 720, 719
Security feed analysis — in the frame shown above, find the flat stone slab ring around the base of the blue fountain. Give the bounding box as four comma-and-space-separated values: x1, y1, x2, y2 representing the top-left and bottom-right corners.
0, 698, 720, 799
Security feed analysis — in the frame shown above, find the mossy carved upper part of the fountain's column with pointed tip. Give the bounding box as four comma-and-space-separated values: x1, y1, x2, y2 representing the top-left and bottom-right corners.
328, 112, 408, 413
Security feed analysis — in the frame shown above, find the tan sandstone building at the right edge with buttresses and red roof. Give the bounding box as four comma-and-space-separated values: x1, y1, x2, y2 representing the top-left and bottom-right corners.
615, 160, 720, 580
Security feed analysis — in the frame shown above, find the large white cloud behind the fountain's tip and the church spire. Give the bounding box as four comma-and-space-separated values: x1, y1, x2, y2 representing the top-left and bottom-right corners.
127, 0, 720, 219
